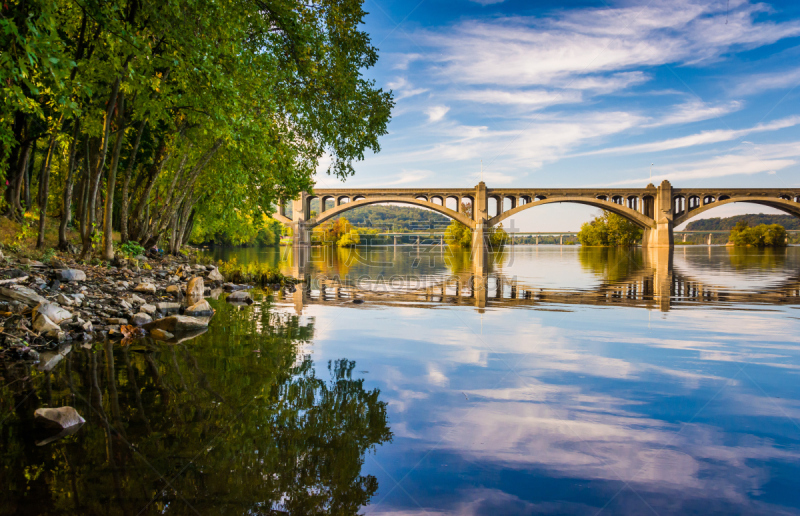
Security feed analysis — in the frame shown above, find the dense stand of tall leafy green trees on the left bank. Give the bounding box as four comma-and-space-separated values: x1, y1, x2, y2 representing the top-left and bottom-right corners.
0, 0, 394, 259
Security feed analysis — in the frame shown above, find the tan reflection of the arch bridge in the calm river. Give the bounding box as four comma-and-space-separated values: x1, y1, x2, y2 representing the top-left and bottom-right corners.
278, 246, 800, 313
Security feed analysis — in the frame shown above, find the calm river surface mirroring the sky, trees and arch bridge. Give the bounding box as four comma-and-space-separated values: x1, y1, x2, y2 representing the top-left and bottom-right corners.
0, 246, 800, 515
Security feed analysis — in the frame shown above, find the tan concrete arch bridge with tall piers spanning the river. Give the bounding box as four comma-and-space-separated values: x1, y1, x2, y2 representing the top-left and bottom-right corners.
274, 180, 800, 247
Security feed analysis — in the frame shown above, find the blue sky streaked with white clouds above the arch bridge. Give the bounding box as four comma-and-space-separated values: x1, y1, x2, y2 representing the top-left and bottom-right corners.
317, 0, 800, 230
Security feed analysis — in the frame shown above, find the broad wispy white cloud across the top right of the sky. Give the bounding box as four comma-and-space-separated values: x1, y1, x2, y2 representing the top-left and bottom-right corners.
425, 0, 800, 87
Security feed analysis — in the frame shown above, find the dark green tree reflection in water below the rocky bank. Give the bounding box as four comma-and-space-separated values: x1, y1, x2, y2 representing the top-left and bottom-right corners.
0, 292, 392, 515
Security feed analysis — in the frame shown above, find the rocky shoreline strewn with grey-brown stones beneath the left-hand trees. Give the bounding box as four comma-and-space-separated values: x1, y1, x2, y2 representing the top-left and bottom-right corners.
0, 250, 252, 367
